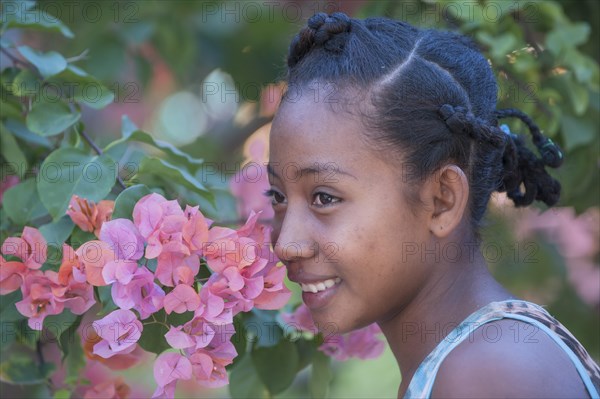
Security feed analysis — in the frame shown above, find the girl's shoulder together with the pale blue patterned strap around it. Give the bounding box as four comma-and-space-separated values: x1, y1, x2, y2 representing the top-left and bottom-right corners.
407, 300, 600, 397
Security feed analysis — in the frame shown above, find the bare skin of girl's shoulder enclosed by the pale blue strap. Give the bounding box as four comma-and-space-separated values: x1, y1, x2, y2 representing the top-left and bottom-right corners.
431, 319, 588, 398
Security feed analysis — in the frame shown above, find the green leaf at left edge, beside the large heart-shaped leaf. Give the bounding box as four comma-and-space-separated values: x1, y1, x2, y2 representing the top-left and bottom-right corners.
2, 177, 48, 226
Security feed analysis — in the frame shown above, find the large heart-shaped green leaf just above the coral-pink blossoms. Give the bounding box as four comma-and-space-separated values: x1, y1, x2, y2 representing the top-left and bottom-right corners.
38, 148, 115, 220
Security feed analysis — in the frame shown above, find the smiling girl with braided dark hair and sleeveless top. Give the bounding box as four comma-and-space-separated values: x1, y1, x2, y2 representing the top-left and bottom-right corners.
268, 13, 600, 398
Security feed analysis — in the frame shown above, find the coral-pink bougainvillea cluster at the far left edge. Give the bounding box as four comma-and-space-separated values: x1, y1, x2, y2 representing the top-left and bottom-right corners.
0, 227, 95, 330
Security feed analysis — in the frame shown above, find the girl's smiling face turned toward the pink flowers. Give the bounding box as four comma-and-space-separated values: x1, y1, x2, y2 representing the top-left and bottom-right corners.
269, 93, 430, 333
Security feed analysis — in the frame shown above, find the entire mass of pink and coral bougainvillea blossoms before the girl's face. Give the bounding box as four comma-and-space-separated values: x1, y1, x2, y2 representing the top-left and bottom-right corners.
0, 193, 290, 397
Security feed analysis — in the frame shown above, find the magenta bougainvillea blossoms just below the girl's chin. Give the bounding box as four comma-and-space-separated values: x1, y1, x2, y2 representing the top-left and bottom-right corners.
282, 304, 385, 361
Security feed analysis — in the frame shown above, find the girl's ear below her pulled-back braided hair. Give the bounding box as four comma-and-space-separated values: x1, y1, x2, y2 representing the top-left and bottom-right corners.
421, 165, 469, 238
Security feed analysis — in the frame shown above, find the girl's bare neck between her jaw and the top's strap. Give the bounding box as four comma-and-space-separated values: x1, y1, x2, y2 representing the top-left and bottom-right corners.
380, 251, 514, 397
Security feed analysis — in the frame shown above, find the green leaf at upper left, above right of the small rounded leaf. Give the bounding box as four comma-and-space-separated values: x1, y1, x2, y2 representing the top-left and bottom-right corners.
49, 65, 115, 109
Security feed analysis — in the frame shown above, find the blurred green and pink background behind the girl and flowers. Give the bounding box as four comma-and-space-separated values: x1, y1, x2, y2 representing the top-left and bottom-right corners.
0, 0, 600, 398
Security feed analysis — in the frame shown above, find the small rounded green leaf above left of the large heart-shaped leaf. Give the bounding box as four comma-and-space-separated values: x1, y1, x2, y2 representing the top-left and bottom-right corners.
25, 101, 81, 136
